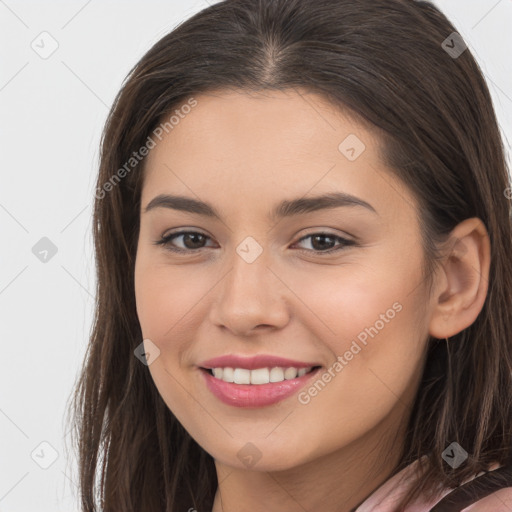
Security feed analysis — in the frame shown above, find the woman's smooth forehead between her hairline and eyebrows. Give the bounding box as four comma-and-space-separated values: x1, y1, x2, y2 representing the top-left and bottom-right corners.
142, 90, 414, 222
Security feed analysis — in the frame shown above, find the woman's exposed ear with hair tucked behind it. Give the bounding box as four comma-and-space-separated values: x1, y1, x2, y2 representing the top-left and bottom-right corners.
429, 217, 491, 339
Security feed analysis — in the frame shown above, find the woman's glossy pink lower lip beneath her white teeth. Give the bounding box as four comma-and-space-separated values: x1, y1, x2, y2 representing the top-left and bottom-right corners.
200, 368, 321, 407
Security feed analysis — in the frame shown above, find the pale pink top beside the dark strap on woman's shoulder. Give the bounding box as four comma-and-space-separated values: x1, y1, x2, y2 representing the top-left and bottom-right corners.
356, 461, 512, 512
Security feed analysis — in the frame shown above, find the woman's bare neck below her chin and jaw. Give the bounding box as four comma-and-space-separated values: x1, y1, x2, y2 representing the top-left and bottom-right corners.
212, 407, 406, 512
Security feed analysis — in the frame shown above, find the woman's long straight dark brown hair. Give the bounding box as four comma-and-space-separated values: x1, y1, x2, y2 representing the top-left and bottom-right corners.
70, 0, 512, 512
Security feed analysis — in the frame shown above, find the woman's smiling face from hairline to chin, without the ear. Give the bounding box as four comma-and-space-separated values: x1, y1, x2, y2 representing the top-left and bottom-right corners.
135, 91, 429, 470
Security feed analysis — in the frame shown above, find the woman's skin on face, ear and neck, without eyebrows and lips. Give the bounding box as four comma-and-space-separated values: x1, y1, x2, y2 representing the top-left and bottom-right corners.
135, 90, 490, 512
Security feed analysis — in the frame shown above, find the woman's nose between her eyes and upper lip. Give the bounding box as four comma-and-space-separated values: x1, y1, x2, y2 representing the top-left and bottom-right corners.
210, 244, 289, 336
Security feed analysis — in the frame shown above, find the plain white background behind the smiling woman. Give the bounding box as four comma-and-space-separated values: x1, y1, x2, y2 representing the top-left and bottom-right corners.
0, 0, 512, 512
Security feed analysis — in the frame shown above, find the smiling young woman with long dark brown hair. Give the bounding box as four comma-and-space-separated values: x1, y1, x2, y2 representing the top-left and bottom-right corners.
68, 0, 512, 512
